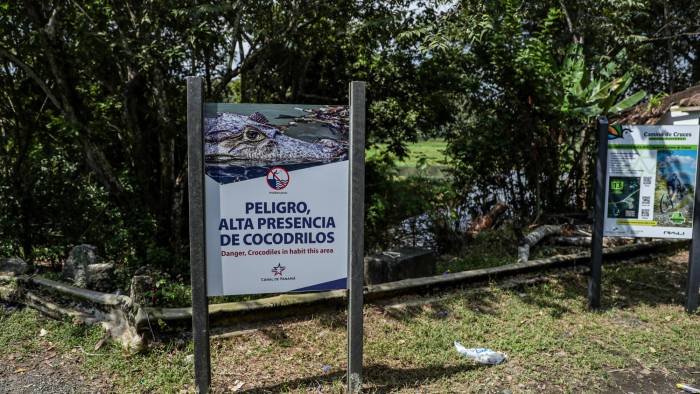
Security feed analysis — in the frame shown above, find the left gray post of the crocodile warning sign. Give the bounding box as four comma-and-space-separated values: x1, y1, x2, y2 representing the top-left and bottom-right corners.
187, 77, 211, 393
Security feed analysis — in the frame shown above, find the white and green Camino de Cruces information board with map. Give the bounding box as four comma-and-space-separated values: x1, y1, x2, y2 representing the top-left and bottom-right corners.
604, 125, 700, 239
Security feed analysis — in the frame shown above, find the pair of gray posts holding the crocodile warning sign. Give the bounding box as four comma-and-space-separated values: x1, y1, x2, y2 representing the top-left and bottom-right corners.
186, 76, 366, 393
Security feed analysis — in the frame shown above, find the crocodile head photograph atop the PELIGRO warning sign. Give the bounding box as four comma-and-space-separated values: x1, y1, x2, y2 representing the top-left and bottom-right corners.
204, 104, 350, 182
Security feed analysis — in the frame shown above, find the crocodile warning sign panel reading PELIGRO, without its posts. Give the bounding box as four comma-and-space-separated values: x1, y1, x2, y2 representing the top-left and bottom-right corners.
203, 104, 350, 296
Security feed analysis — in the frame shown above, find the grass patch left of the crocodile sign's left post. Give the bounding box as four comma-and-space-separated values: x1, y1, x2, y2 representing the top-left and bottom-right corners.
0, 304, 194, 392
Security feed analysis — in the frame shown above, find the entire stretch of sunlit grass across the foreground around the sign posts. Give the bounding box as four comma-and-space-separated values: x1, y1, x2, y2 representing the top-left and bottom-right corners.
0, 253, 700, 393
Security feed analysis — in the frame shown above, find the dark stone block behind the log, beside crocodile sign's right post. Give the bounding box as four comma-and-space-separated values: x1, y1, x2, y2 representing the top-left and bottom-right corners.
365, 248, 437, 285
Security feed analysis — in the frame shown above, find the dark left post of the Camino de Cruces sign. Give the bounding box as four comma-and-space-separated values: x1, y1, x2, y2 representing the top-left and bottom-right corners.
588, 116, 608, 309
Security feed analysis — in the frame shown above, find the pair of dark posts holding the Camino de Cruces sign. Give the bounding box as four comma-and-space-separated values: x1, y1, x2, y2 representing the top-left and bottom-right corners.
588, 116, 700, 313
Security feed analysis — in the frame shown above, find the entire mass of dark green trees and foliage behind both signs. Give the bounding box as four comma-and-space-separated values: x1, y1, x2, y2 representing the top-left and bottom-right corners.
0, 0, 700, 275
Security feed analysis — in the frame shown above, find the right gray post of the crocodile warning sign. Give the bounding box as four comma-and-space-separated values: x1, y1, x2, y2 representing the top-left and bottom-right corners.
348, 82, 365, 393
